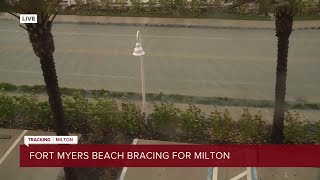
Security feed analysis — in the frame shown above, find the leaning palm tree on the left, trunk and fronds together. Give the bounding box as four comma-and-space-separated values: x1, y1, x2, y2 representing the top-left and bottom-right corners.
0, 0, 76, 180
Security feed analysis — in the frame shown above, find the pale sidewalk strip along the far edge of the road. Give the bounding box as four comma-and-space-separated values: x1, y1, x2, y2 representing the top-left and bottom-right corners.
0, 14, 320, 30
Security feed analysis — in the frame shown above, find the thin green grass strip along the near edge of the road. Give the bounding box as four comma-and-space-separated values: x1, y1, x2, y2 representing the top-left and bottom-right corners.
0, 83, 320, 110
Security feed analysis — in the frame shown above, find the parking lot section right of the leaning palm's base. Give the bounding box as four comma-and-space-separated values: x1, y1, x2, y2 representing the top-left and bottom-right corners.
120, 139, 320, 180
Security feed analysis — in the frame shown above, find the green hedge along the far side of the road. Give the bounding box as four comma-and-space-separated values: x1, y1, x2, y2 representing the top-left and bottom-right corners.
60, 0, 320, 20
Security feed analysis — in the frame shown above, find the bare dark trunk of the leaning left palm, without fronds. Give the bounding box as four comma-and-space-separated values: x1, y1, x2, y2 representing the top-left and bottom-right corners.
27, 25, 77, 180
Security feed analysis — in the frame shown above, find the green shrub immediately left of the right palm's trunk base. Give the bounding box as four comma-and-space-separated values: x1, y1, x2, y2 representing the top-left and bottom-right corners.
239, 109, 266, 143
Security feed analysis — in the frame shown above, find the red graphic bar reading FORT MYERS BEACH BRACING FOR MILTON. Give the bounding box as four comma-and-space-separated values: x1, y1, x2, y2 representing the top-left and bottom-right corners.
20, 145, 320, 167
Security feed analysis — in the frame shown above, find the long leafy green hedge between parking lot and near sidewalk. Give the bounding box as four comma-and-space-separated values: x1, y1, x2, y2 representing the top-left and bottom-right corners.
0, 93, 320, 144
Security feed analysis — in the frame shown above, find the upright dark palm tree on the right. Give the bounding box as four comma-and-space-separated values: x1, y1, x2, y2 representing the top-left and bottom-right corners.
271, 1, 293, 144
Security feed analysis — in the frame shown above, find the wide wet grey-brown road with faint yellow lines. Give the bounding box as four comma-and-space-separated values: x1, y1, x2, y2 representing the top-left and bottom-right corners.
0, 21, 320, 102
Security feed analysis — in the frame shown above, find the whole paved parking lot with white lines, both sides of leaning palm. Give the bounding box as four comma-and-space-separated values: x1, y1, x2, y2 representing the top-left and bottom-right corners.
0, 128, 320, 180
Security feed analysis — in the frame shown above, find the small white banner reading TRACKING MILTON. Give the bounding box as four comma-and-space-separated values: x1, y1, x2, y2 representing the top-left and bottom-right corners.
24, 136, 78, 147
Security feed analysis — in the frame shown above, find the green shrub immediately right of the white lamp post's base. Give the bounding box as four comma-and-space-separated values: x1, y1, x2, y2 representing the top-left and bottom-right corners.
151, 103, 181, 140
